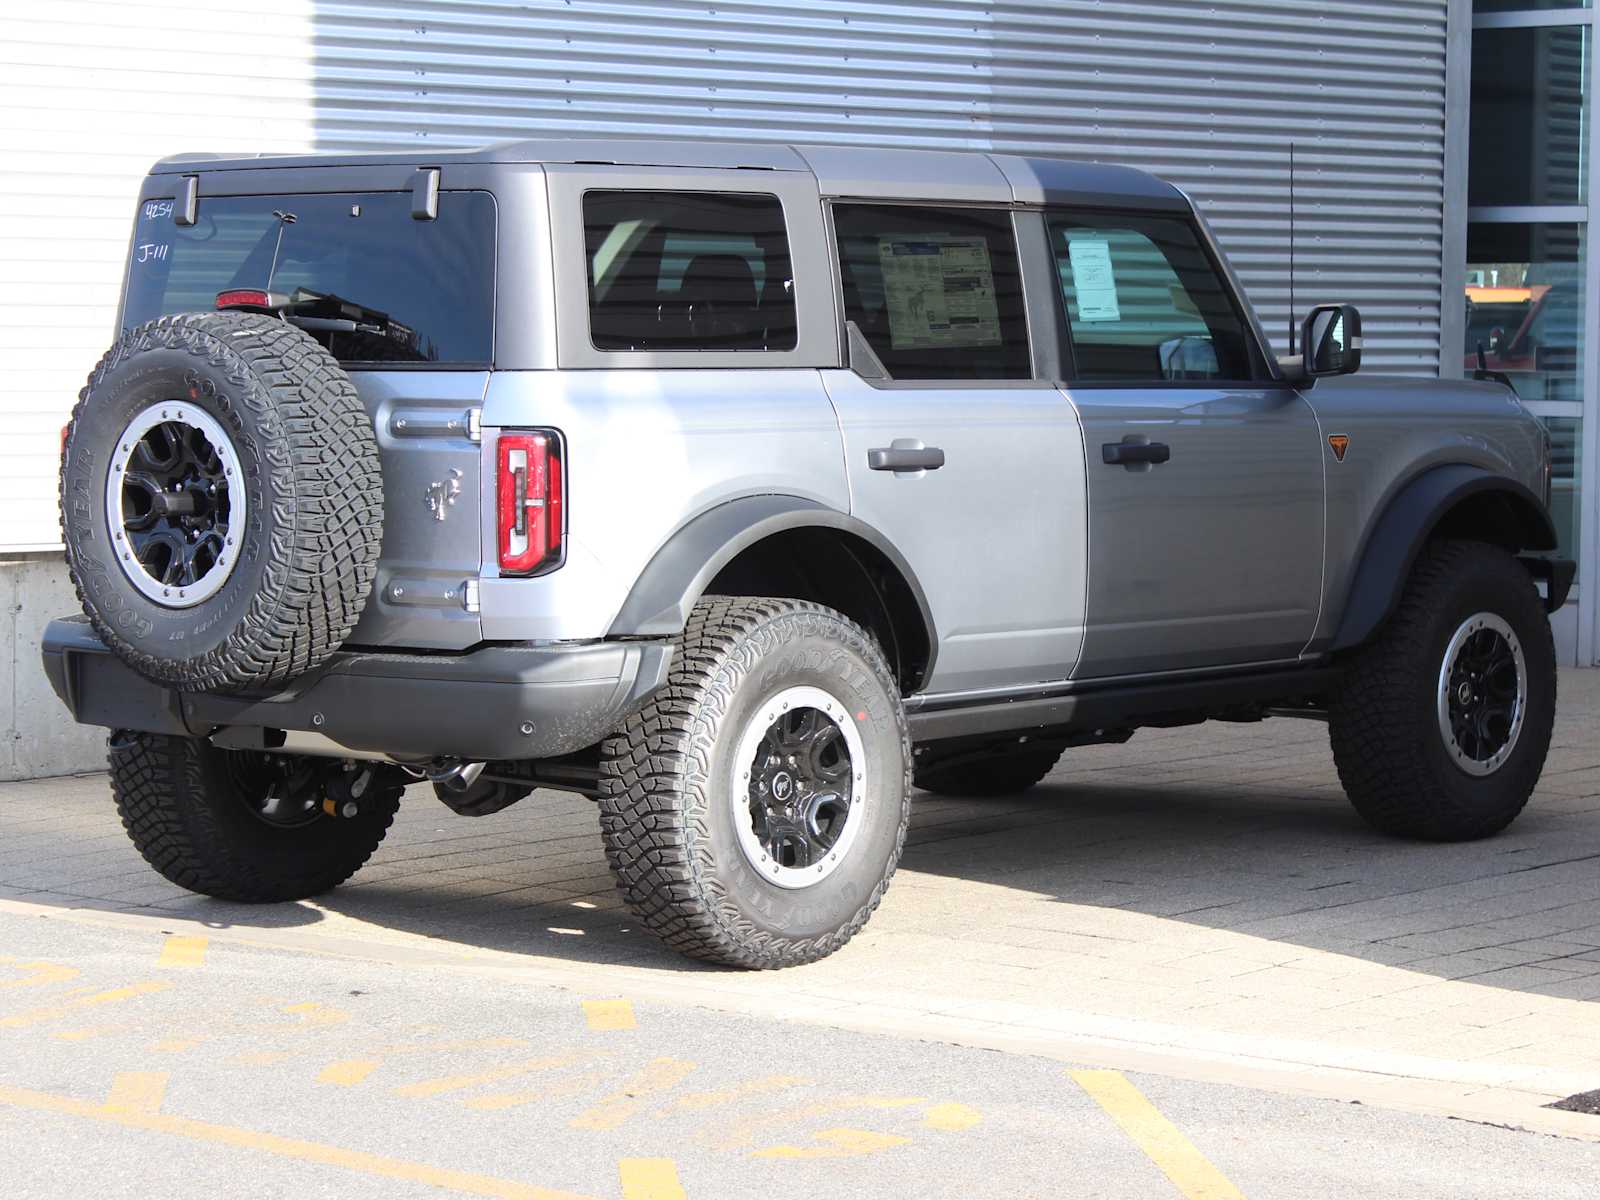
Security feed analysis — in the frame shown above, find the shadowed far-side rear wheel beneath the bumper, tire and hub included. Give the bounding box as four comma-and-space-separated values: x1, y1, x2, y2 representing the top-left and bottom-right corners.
109, 733, 403, 904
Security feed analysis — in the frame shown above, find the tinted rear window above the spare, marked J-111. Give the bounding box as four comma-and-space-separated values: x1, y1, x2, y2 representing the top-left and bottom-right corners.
123, 192, 494, 365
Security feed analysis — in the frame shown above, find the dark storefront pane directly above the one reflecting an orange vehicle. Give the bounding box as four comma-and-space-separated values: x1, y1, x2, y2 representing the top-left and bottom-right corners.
1467, 24, 1589, 206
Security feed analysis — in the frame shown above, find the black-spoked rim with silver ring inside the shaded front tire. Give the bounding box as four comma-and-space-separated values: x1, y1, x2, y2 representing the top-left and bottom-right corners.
1437, 613, 1528, 776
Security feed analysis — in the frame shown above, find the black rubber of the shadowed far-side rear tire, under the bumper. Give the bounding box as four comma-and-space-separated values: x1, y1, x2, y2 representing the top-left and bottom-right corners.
107, 733, 402, 904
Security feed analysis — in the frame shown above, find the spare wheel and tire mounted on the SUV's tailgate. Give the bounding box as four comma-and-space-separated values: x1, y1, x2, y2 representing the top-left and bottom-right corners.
61, 312, 384, 691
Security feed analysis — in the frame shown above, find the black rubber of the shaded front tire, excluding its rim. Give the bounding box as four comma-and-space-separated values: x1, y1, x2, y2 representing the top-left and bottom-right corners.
1328, 539, 1555, 842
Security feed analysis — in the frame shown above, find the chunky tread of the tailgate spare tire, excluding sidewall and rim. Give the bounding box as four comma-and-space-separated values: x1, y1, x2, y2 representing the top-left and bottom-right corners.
61, 312, 384, 693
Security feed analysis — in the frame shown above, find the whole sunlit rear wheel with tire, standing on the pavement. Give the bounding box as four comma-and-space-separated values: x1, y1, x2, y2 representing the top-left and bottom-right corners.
600, 598, 910, 968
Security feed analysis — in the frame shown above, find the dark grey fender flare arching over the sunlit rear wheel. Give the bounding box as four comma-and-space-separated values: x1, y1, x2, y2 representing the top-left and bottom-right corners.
606, 496, 939, 649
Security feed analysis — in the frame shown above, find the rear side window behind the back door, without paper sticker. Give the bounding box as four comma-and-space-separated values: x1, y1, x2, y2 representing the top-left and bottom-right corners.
584, 192, 795, 350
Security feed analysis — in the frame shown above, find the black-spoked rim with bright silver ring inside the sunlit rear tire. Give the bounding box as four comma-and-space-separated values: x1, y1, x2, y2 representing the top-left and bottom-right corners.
728, 688, 867, 890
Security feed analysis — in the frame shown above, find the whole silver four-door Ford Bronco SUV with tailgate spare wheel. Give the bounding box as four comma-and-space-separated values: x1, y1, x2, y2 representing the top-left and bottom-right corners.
43, 141, 1573, 966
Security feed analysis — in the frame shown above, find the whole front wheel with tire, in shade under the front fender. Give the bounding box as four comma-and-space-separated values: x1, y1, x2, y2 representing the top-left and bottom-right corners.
1328, 541, 1555, 842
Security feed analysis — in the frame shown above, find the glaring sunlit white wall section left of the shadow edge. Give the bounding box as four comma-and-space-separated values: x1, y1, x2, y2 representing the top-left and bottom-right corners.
0, 0, 314, 550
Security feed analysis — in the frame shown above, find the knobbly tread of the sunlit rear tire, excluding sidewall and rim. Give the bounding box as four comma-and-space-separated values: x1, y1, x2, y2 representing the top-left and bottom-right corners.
600, 597, 910, 970
